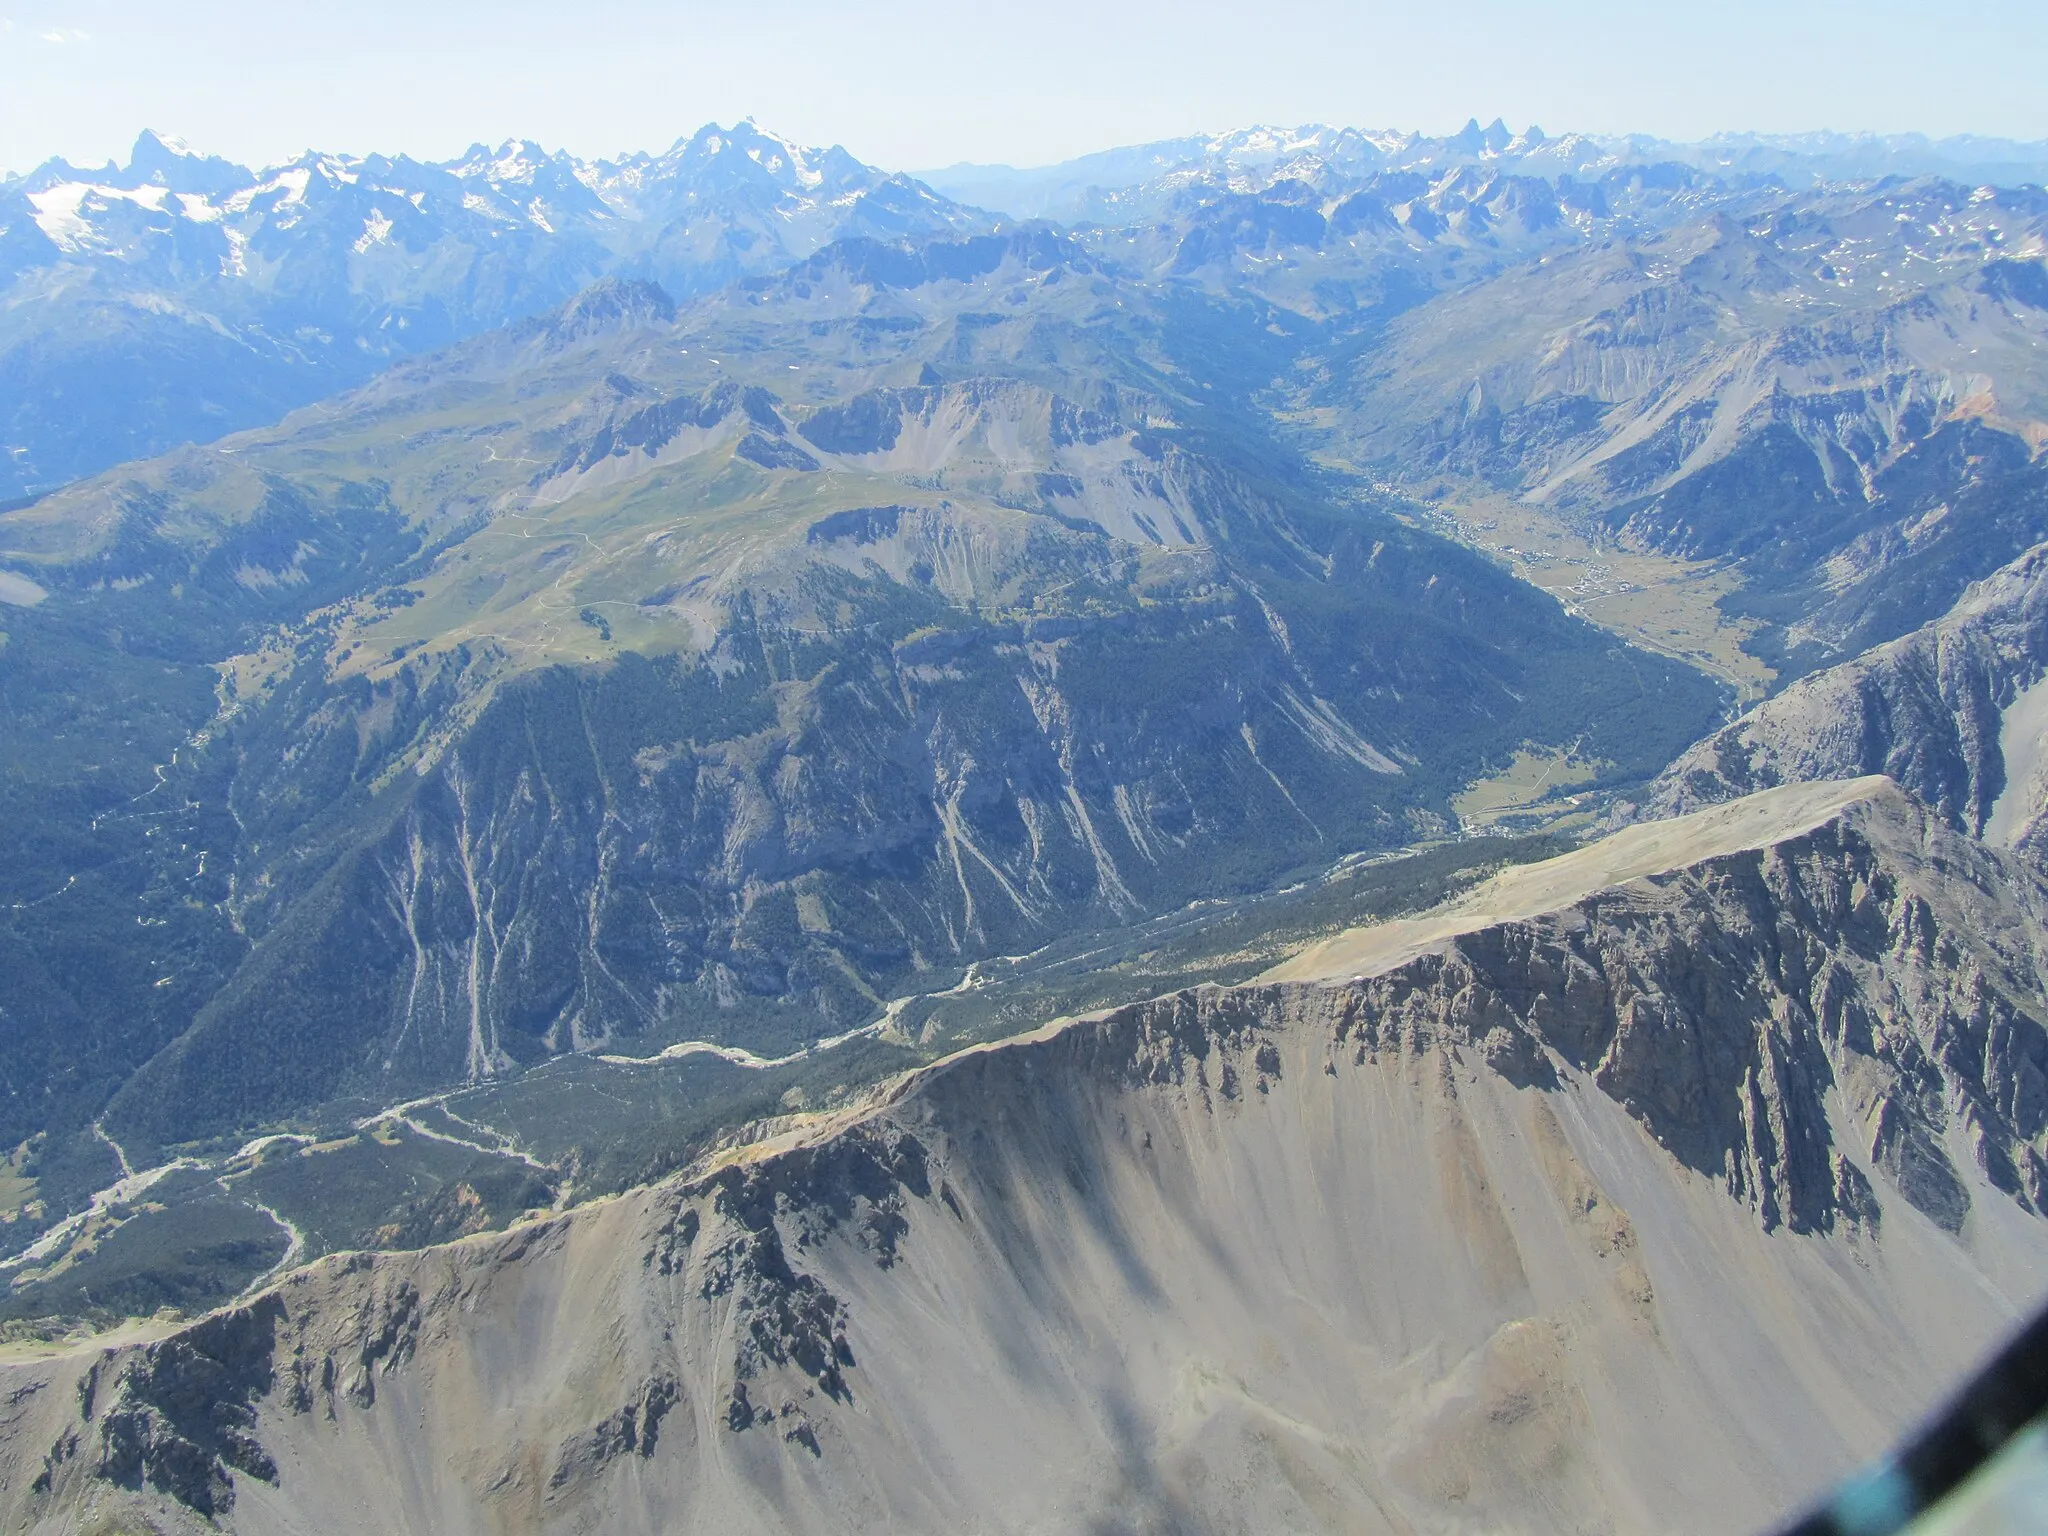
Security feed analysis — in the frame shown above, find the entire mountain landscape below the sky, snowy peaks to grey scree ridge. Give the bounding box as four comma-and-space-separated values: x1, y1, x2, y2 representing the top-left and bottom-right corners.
0, 121, 2048, 1532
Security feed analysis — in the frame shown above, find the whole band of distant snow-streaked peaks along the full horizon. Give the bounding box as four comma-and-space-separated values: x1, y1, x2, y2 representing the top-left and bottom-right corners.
16, 121, 2048, 500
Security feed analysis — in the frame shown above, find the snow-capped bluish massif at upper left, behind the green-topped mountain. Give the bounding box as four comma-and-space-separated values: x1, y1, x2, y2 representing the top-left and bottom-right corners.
0, 123, 989, 498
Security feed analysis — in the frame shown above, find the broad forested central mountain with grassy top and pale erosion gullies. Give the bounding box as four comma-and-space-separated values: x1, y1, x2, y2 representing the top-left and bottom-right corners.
0, 246, 1716, 1179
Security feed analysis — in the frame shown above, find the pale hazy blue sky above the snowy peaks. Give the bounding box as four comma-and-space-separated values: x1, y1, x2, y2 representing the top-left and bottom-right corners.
0, 0, 2048, 170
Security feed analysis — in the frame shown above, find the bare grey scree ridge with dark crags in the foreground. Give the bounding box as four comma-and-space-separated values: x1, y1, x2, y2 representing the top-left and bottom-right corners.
12, 784, 2048, 1532
